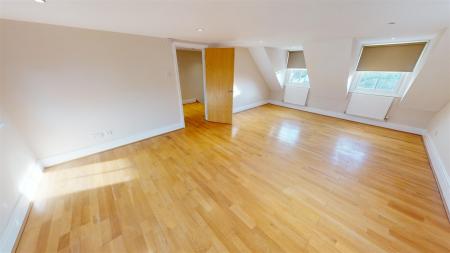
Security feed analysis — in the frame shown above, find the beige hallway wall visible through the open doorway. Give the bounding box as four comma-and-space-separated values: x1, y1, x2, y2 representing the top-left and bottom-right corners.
177, 49, 204, 104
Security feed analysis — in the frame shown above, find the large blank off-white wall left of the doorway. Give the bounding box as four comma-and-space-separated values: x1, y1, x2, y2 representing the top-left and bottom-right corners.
0, 20, 182, 165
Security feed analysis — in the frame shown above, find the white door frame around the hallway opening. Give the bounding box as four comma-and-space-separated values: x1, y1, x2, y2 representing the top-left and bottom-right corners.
172, 41, 208, 128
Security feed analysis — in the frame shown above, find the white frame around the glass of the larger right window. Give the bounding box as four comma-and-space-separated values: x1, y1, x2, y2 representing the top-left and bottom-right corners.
350, 71, 410, 97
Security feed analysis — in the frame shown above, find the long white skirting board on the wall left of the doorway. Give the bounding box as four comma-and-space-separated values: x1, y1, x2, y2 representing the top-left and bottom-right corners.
40, 122, 184, 168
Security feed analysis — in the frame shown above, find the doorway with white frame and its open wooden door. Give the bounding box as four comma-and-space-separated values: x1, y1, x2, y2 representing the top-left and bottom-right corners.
173, 42, 234, 127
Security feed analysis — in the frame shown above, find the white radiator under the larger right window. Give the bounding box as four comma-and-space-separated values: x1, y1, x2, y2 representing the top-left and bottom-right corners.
346, 93, 394, 120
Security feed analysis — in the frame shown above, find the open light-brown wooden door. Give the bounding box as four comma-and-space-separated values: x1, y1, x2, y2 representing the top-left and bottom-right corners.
205, 48, 234, 124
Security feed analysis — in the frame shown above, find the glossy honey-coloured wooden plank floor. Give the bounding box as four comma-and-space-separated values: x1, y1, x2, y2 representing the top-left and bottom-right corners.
18, 104, 450, 253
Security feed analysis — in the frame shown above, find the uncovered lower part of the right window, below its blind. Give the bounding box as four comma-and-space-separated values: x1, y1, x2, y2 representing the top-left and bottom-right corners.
352, 71, 407, 96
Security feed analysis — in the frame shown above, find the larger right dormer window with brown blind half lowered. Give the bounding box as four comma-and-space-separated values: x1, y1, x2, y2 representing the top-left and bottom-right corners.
350, 42, 426, 97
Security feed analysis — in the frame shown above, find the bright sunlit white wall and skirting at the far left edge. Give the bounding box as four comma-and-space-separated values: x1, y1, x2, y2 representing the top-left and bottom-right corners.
0, 107, 41, 252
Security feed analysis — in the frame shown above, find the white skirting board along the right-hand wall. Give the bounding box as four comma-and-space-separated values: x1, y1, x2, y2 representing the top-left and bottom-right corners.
423, 133, 450, 221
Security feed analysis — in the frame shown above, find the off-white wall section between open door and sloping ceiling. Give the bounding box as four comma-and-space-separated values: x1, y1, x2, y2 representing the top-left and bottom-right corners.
233, 48, 269, 111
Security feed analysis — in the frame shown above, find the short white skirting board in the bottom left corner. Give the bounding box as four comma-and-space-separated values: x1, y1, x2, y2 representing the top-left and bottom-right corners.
0, 195, 30, 252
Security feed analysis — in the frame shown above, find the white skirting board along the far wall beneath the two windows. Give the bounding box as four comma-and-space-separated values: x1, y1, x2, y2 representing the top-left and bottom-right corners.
269, 99, 427, 135
